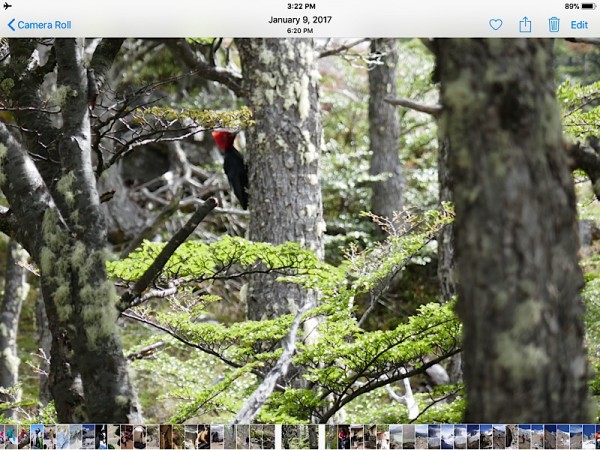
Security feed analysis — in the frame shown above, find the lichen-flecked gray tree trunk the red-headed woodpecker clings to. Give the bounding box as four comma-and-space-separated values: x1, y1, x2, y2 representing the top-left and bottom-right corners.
236, 39, 325, 320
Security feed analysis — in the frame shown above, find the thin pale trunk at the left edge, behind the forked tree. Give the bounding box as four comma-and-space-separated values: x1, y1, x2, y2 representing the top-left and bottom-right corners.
0, 239, 29, 418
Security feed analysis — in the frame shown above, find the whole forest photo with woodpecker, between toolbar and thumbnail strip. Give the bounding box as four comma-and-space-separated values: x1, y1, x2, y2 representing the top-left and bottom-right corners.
0, 38, 600, 426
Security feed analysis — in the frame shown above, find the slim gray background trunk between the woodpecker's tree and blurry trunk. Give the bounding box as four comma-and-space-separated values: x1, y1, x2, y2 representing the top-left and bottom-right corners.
369, 39, 404, 223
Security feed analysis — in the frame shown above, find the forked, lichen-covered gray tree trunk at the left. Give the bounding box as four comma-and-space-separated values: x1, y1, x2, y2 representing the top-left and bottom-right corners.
0, 39, 141, 423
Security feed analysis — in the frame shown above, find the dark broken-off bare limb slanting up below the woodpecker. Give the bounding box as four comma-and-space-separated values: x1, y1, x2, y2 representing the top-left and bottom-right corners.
117, 198, 218, 312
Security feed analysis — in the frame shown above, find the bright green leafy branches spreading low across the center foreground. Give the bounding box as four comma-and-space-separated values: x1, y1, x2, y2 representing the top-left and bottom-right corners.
108, 207, 460, 423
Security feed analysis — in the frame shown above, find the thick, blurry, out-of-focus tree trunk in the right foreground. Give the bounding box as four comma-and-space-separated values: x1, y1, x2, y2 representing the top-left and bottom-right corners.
436, 39, 590, 423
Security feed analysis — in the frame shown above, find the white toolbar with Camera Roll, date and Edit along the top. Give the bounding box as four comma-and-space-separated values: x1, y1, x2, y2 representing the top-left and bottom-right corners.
0, 0, 600, 39
